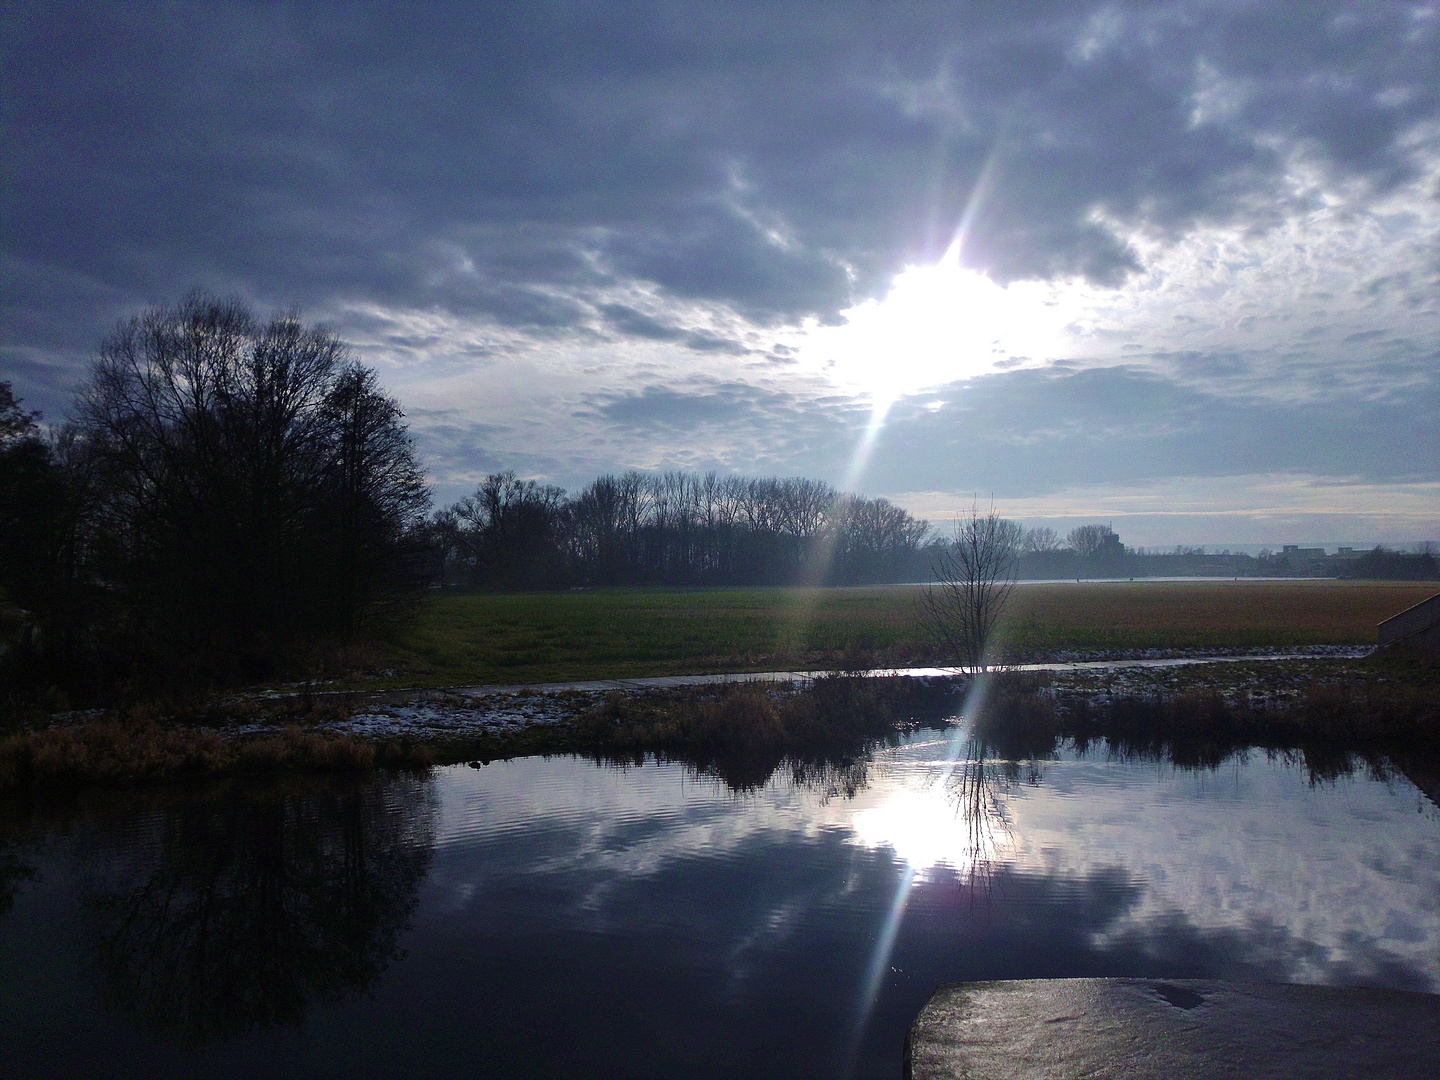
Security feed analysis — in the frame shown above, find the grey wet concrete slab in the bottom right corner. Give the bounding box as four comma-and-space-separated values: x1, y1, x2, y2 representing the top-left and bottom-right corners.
904, 979, 1440, 1080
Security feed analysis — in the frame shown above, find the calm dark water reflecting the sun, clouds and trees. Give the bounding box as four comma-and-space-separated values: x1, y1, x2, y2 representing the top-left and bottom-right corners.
0, 729, 1440, 1077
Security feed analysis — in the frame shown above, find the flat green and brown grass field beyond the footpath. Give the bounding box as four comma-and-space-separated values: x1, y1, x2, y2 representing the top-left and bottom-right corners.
367, 580, 1436, 687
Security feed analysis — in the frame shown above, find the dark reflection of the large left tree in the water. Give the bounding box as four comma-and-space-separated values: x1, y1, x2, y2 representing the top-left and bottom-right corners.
79, 778, 435, 1043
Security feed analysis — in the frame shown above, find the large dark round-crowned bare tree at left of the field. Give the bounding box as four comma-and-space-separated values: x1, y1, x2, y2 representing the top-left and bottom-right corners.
78, 292, 428, 674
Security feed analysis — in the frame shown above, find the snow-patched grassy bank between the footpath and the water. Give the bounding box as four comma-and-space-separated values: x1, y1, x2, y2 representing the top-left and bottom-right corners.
0, 647, 1440, 792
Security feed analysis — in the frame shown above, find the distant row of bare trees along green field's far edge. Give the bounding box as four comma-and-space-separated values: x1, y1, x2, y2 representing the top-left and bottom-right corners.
429, 471, 927, 589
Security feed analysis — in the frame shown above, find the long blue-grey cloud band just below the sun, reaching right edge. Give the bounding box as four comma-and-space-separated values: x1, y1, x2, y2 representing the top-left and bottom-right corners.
846, 367, 1440, 497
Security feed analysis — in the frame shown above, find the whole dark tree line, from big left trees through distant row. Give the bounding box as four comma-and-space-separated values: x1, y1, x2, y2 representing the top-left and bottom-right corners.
0, 292, 927, 698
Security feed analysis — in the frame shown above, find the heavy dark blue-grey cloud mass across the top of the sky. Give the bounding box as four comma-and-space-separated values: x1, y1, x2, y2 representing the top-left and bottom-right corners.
6, 4, 1440, 334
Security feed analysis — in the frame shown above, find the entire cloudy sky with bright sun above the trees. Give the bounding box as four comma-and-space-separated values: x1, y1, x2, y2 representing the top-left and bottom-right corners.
0, 1, 1440, 544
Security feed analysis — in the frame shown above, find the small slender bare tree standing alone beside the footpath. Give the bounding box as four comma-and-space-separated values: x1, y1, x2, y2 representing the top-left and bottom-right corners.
923, 505, 1024, 671
